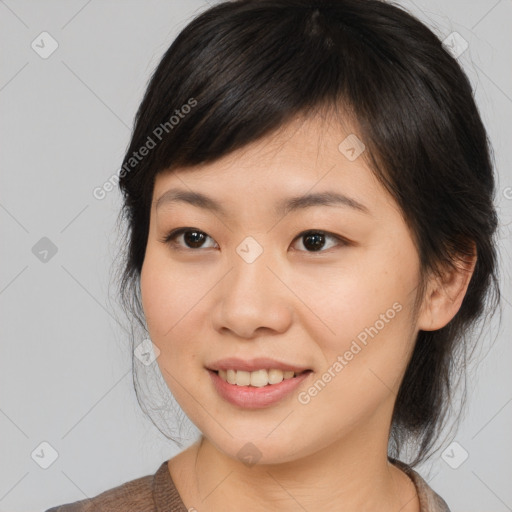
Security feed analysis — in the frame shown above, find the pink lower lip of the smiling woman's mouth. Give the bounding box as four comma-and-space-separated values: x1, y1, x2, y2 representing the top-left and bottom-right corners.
208, 370, 312, 409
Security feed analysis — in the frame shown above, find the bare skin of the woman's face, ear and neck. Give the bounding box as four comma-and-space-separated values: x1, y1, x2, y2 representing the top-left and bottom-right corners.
141, 117, 474, 512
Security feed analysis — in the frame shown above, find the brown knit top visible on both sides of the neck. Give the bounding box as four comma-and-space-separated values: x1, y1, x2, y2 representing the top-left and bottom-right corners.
46, 459, 450, 512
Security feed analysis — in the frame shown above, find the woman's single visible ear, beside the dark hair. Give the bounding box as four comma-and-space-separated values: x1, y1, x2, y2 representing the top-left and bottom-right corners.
417, 243, 477, 331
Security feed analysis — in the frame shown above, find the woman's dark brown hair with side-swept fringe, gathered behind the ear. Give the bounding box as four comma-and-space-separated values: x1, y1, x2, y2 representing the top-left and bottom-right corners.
112, 0, 500, 465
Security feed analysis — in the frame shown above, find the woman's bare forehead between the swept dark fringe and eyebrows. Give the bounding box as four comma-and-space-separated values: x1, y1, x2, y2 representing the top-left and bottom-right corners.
153, 112, 394, 216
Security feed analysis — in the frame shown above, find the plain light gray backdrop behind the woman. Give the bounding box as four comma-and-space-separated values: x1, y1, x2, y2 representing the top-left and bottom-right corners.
0, 0, 512, 512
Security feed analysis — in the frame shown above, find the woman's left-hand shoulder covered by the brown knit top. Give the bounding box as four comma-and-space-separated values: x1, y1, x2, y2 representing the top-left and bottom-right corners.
46, 461, 174, 512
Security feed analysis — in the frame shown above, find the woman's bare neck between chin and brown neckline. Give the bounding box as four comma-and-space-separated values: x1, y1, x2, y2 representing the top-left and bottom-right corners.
181, 418, 420, 512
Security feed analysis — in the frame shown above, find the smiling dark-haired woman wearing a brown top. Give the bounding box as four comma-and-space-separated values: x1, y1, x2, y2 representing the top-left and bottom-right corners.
45, 0, 499, 512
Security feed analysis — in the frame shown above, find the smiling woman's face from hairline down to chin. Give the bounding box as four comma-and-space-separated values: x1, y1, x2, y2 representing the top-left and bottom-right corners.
141, 114, 419, 463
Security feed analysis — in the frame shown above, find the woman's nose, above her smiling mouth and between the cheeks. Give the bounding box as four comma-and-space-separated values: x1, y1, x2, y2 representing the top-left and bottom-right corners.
212, 249, 293, 338
